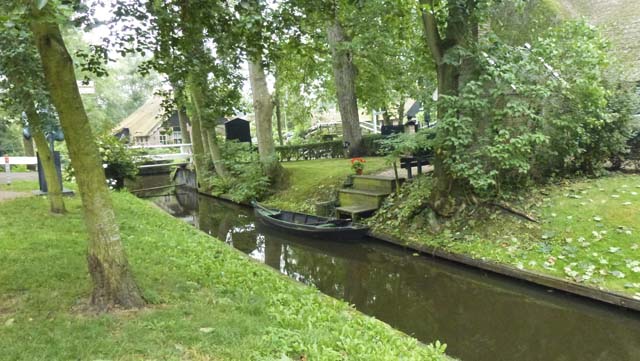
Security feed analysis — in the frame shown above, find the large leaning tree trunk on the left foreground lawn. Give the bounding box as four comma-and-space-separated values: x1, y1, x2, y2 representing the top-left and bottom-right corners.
31, 18, 144, 310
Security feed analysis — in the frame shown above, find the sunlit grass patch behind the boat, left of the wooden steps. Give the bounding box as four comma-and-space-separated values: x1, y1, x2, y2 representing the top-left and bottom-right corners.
265, 157, 390, 213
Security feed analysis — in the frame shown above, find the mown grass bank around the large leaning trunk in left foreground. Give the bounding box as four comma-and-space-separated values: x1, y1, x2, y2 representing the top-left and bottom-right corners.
0, 193, 444, 361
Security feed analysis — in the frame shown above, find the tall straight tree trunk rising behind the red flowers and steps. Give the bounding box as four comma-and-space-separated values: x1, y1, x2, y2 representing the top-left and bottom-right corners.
327, 19, 362, 157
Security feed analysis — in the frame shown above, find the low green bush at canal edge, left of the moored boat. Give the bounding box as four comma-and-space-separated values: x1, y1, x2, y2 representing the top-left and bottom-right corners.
209, 141, 270, 202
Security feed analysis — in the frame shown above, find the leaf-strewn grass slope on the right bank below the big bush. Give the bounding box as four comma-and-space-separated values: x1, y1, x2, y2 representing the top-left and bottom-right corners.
372, 174, 640, 299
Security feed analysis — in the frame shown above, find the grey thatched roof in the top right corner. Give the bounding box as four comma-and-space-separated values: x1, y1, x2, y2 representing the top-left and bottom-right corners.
557, 0, 640, 81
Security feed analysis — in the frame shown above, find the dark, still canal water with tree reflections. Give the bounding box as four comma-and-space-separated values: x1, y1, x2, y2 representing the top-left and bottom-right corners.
144, 190, 640, 361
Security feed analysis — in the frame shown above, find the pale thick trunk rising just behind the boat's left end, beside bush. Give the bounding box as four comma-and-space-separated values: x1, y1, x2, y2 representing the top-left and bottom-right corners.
249, 59, 282, 180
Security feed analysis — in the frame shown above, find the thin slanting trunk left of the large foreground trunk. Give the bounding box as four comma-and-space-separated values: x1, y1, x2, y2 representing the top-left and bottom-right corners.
23, 99, 66, 214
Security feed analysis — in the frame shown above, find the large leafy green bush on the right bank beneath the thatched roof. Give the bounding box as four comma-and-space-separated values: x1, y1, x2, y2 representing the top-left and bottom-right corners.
435, 22, 630, 196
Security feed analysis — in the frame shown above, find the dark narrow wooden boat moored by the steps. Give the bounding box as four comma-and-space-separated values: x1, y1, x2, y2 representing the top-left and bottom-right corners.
251, 202, 369, 241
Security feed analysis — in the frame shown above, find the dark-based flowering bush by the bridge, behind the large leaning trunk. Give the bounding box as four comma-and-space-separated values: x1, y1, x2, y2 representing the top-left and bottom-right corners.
64, 134, 139, 189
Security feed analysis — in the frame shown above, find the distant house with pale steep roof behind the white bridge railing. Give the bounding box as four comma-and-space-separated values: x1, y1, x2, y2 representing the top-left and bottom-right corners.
113, 95, 191, 145
